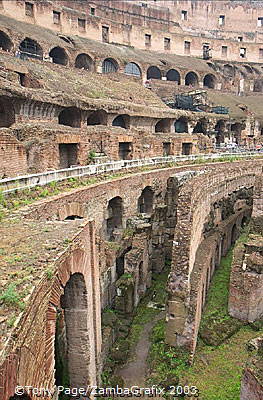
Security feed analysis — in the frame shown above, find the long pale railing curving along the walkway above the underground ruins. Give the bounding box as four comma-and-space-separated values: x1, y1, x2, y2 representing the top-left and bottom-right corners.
0, 152, 263, 193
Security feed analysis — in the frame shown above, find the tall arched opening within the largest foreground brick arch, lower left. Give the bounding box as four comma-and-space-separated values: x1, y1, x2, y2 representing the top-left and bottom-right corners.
56, 273, 90, 388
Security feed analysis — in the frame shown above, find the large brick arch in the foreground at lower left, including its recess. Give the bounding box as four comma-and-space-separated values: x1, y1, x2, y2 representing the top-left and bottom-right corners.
45, 223, 101, 387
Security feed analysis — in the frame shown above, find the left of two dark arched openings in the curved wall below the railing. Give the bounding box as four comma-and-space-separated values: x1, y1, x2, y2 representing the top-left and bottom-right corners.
106, 196, 123, 241
